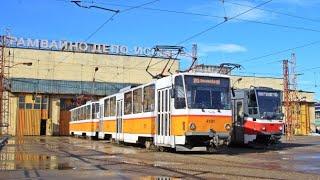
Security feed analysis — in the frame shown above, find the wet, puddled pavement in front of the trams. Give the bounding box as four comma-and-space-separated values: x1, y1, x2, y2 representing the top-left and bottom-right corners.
0, 136, 320, 179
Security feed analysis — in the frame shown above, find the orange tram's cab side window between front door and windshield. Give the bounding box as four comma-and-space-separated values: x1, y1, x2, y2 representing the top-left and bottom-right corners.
174, 76, 186, 109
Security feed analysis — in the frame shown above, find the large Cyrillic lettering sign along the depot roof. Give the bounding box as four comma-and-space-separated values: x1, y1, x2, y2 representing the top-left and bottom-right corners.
1, 36, 154, 56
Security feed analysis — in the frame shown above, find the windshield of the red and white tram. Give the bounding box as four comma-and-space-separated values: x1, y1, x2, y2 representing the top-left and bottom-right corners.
256, 90, 282, 119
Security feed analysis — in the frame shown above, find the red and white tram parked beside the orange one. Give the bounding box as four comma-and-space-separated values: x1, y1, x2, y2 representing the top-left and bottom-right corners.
232, 87, 284, 145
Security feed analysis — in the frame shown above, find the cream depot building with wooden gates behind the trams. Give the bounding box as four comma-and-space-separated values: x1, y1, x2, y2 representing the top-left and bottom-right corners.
1, 39, 315, 136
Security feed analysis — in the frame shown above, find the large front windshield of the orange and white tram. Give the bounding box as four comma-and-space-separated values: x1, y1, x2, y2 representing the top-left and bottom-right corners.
185, 76, 230, 109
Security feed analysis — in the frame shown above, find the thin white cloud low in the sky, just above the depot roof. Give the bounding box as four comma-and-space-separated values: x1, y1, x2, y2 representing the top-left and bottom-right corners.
198, 43, 247, 56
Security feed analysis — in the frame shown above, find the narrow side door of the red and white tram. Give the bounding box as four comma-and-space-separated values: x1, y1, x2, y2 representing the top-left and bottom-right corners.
233, 99, 244, 143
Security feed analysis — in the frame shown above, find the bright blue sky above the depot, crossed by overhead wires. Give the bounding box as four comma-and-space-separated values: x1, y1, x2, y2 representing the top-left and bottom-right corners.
0, 0, 320, 99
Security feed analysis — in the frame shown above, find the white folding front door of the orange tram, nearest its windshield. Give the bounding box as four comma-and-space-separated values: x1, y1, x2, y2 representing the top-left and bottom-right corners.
155, 88, 171, 145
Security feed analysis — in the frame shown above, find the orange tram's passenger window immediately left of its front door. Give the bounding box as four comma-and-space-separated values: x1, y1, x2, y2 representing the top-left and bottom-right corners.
143, 84, 155, 112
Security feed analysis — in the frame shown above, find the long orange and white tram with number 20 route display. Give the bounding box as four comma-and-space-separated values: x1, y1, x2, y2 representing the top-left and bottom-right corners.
70, 72, 232, 151
